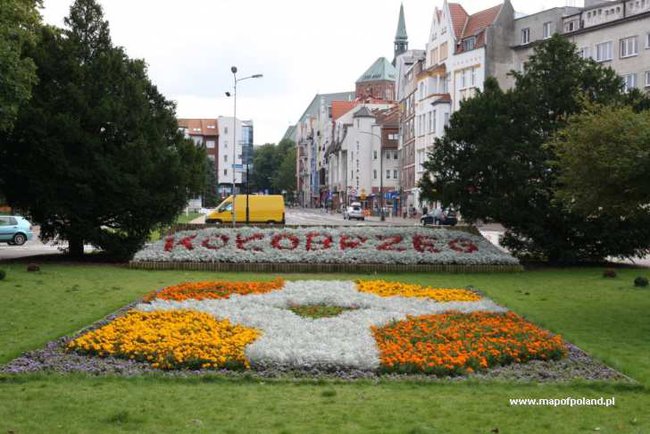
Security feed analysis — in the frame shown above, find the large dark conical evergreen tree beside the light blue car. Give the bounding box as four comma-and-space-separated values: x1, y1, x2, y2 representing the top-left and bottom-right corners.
0, 0, 206, 258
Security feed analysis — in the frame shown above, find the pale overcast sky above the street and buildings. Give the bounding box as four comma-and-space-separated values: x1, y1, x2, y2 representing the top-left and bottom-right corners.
42, 0, 583, 145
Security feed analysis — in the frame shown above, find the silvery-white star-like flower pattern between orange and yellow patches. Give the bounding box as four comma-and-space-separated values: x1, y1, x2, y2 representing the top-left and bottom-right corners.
137, 281, 507, 371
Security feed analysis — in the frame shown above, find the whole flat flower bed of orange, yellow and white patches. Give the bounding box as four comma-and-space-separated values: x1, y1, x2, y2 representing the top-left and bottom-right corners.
63, 280, 564, 375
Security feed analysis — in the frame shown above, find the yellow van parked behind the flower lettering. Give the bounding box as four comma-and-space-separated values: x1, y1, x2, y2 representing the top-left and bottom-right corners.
205, 194, 284, 224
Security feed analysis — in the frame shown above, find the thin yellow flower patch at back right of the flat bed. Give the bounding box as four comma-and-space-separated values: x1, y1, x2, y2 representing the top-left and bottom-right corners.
356, 280, 481, 302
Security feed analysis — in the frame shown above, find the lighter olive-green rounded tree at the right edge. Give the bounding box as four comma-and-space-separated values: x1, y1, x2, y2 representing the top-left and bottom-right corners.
553, 107, 650, 219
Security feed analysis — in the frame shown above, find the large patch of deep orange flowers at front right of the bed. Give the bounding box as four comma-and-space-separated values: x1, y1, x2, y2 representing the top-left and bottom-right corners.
372, 312, 566, 375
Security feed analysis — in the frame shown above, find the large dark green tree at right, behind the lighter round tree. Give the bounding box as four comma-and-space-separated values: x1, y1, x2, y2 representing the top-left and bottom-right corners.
420, 35, 650, 262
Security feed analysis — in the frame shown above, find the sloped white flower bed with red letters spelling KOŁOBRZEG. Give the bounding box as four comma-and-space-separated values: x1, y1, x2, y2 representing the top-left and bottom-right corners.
133, 226, 518, 265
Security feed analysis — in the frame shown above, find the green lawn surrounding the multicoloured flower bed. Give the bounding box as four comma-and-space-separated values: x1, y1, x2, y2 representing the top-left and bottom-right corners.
0, 264, 650, 433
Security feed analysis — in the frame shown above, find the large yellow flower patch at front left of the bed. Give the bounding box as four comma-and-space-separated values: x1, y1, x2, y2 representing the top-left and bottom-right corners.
68, 310, 260, 369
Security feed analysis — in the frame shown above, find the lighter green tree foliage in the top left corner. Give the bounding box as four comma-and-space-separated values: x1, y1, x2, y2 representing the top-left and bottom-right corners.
0, 0, 41, 132
